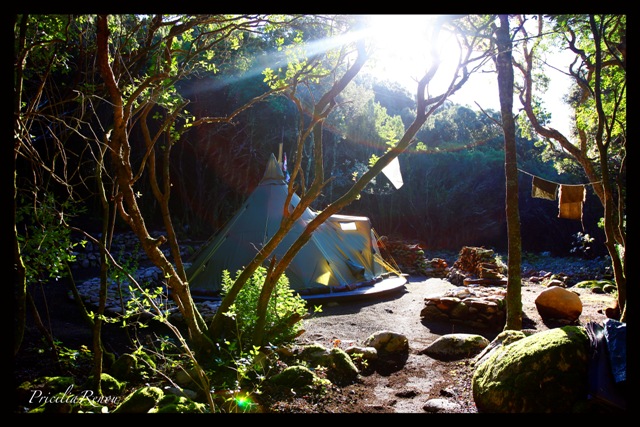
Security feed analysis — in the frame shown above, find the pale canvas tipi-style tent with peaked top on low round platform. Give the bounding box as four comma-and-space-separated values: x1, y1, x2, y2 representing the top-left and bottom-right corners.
187, 155, 406, 298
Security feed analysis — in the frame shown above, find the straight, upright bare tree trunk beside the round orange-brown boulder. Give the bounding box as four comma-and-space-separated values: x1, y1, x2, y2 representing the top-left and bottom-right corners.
496, 15, 522, 330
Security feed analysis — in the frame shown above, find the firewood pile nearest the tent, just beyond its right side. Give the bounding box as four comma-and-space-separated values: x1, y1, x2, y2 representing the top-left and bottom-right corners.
380, 239, 449, 277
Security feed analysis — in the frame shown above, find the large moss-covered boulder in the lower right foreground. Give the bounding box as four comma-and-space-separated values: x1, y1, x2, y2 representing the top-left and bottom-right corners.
472, 326, 590, 413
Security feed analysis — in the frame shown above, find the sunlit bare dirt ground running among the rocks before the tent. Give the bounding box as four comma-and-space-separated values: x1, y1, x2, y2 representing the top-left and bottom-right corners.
271, 277, 613, 413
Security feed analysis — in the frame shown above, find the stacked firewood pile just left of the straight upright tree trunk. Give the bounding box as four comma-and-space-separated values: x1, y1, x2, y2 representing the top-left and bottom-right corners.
453, 246, 505, 285
